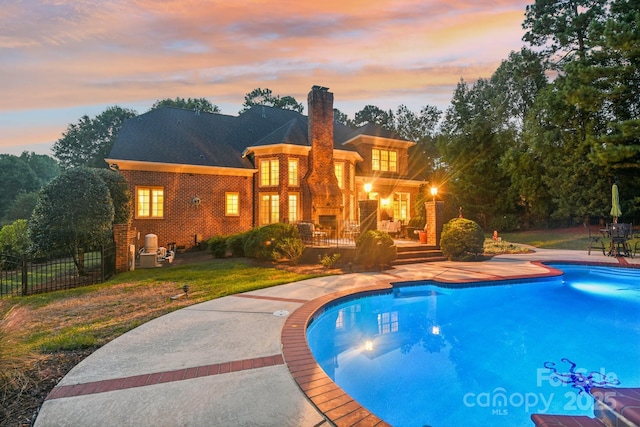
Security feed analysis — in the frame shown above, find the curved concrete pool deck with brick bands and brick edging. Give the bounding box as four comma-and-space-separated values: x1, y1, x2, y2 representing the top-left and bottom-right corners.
35, 249, 640, 427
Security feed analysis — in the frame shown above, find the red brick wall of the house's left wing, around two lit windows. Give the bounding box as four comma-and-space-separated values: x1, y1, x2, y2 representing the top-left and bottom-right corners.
121, 170, 253, 248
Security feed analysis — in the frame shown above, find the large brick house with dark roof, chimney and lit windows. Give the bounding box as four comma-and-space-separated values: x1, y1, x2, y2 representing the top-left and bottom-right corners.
105, 86, 422, 248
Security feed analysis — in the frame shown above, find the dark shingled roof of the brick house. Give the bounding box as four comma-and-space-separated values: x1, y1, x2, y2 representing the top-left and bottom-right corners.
109, 105, 398, 168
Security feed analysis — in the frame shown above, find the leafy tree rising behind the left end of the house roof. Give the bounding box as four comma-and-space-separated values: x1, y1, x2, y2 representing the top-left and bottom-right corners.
53, 106, 138, 169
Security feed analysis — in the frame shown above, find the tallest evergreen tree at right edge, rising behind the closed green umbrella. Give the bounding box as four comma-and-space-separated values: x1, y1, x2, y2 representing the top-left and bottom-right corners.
523, 0, 640, 222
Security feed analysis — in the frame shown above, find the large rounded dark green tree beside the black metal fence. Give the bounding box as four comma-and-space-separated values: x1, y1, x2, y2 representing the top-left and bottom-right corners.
29, 167, 114, 274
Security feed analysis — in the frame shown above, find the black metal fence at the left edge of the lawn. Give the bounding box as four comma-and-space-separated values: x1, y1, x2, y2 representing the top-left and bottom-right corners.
0, 244, 116, 298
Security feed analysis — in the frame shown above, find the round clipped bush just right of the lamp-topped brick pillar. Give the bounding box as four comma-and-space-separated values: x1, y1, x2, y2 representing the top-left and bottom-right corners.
440, 218, 484, 261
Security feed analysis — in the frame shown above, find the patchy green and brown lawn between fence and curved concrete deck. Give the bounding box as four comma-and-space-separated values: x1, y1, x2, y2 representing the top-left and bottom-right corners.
0, 260, 320, 359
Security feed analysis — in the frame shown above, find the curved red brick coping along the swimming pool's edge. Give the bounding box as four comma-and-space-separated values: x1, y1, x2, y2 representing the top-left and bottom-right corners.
281, 258, 637, 427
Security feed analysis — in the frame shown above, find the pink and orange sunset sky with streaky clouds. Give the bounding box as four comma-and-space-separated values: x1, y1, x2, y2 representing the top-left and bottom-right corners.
0, 0, 533, 155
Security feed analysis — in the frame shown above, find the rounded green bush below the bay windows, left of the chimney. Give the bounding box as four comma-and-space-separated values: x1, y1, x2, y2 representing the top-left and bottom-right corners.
244, 223, 300, 261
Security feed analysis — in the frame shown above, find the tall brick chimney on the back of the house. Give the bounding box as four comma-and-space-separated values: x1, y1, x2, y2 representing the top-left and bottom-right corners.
307, 86, 342, 225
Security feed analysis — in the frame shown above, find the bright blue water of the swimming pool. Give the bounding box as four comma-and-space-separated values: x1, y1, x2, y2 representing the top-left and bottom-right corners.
307, 264, 640, 427
